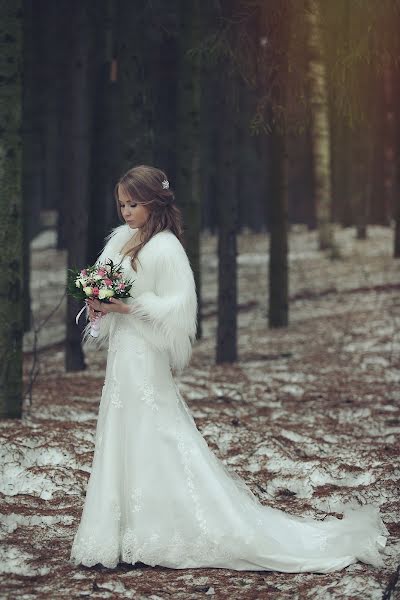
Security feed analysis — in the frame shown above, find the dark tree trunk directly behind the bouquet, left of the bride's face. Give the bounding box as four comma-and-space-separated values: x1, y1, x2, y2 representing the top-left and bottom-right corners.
64, 0, 93, 371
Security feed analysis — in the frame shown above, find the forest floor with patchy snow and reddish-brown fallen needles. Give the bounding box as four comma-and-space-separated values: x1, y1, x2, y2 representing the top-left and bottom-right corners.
0, 227, 400, 600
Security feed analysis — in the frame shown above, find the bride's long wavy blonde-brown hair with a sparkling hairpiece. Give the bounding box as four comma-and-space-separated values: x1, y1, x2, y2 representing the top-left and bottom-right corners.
114, 165, 183, 271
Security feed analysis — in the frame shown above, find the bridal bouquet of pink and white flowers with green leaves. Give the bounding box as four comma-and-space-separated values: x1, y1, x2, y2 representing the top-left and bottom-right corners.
67, 258, 133, 337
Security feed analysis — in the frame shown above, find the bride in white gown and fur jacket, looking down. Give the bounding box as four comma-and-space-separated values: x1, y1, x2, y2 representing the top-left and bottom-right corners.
70, 165, 389, 573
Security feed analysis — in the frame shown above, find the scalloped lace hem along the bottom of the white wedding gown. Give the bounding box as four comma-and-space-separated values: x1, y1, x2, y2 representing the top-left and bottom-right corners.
69, 505, 389, 573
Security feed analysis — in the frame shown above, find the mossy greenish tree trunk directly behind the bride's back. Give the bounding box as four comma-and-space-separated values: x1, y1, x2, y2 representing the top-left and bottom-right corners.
175, 0, 201, 337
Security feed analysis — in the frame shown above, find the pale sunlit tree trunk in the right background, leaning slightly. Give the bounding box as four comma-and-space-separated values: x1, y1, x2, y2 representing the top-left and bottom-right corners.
306, 0, 334, 250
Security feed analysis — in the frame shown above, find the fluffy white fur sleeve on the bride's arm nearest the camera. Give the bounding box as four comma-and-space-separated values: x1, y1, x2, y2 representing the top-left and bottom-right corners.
125, 233, 197, 371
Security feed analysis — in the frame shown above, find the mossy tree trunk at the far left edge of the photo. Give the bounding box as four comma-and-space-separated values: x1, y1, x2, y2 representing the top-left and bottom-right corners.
0, 0, 23, 418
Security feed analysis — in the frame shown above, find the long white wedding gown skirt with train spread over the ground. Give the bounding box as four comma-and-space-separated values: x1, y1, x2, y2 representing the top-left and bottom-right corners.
70, 315, 389, 573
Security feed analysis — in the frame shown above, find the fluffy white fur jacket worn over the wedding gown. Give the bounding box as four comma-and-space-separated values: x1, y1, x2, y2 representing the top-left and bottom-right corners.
84, 225, 197, 371
